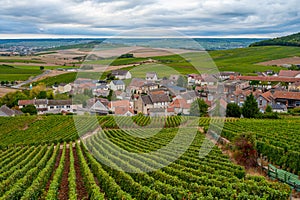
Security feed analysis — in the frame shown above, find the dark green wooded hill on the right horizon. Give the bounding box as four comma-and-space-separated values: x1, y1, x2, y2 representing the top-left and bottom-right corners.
250, 33, 300, 47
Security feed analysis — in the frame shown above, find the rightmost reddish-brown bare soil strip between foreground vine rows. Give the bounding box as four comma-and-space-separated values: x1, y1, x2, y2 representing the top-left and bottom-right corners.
72, 148, 88, 199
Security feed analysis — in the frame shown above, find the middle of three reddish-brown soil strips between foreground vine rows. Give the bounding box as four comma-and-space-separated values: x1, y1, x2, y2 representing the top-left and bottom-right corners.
58, 148, 70, 200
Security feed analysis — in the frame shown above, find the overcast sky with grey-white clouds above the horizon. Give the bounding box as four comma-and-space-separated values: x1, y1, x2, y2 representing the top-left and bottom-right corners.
0, 0, 300, 38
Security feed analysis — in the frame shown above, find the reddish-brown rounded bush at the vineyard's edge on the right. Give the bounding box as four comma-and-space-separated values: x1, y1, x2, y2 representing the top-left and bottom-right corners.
233, 132, 257, 169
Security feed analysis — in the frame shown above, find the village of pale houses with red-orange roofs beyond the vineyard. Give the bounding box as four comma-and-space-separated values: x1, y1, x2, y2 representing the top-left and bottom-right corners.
0, 67, 300, 116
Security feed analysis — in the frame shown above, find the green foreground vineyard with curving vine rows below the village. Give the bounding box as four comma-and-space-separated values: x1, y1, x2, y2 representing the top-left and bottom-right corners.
0, 115, 299, 200
